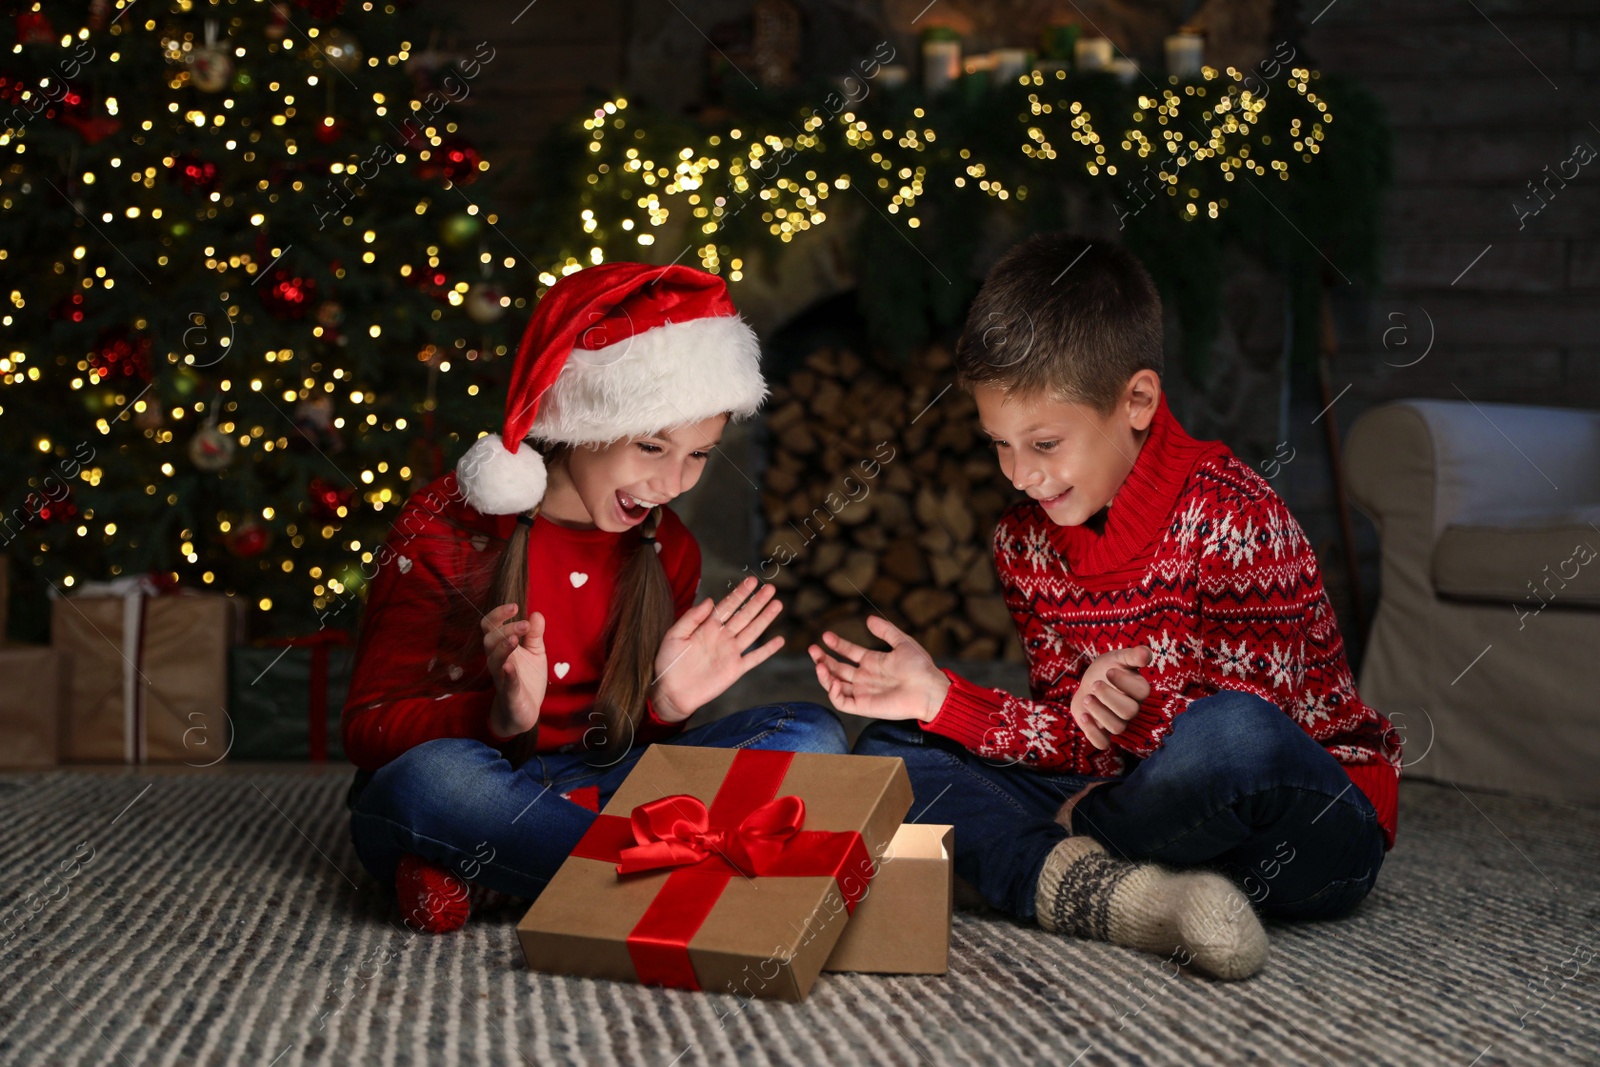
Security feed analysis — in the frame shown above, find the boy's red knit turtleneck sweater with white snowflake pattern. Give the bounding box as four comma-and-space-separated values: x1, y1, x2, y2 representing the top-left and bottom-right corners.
925, 394, 1400, 848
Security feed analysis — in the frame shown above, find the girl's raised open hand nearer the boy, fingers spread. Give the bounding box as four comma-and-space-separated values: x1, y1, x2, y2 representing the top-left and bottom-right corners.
650, 577, 784, 723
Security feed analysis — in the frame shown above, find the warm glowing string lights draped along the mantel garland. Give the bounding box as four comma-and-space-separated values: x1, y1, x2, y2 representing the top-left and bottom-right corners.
539, 67, 1333, 286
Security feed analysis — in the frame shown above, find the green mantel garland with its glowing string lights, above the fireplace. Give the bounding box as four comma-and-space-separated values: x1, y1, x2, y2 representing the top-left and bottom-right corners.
541, 67, 1390, 381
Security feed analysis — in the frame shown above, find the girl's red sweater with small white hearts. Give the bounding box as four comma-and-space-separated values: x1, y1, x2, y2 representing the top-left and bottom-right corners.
342, 474, 701, 769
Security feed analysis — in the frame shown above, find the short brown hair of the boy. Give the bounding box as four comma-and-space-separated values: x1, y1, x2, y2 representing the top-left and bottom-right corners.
955, 234, 1162, 414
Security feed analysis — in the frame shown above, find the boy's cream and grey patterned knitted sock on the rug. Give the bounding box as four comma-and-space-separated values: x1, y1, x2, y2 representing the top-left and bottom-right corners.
1035, 837, 1267, 979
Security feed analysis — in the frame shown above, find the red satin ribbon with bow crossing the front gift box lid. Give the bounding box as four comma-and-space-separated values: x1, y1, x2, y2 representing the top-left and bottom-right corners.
573, 749, 872, 989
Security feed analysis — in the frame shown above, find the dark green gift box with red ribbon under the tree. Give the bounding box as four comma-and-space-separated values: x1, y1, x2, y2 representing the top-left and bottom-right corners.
229, 630, 355, 763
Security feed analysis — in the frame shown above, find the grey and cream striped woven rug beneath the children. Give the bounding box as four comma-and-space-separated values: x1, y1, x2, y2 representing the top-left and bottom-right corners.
0, 773, 1600, 1067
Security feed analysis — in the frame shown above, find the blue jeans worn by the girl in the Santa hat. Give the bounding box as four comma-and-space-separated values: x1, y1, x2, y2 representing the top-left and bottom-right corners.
346, 704, 850, 899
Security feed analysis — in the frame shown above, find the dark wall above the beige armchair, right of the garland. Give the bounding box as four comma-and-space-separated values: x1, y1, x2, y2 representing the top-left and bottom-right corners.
1302, 0, 1600, 412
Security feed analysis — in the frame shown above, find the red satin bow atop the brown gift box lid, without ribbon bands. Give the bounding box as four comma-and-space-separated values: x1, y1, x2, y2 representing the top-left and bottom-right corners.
616, 793, 805, 877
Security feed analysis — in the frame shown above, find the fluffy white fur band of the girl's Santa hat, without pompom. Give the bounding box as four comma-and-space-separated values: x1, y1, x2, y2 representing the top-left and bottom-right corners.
528, 315, 766, 445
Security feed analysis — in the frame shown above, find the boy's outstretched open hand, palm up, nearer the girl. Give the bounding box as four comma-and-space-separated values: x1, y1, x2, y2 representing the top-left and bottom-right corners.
806, 614, 950, 723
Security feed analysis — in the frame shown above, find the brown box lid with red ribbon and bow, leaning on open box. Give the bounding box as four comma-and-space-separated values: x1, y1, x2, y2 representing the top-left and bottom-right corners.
517, 745, 912, 1000
